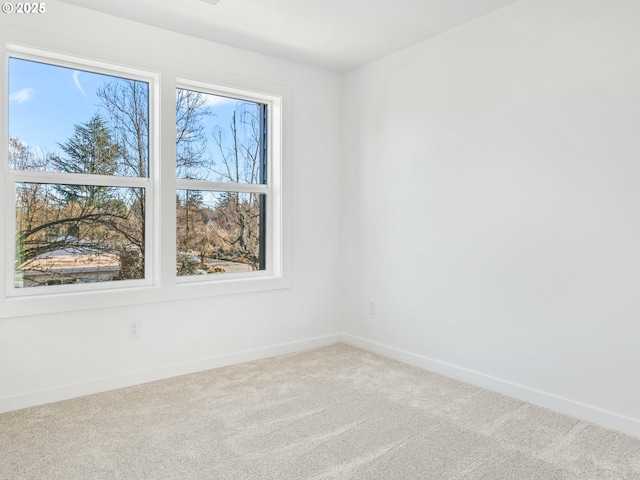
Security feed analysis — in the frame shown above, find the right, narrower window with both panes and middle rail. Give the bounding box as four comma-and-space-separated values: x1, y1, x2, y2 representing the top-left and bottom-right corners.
176, 87, 271, 277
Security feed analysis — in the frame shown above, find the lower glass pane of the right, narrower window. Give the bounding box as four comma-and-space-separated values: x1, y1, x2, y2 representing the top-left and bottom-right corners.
176, 190, 265, 276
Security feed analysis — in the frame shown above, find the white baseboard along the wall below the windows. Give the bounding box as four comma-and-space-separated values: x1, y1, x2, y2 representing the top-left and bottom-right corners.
0, 335, 343, 413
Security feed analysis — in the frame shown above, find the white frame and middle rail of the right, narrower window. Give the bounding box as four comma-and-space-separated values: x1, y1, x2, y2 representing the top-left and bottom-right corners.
176, 78, 282, 284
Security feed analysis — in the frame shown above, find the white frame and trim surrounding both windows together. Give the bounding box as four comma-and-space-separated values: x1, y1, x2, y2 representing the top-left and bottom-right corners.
0, 42, 291, 319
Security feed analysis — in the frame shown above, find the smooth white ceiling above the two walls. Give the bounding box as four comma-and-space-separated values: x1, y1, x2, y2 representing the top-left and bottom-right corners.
61, 0, 517, 72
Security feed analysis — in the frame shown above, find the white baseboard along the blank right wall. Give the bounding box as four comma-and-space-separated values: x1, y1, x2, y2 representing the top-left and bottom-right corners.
342, 333, 640, 437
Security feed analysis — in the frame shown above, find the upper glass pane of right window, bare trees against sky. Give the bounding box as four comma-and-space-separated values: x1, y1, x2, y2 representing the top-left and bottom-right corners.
176, 88, 267, 184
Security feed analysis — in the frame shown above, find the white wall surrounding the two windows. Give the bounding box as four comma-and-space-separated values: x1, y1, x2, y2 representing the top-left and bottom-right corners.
0, 0, 340, 411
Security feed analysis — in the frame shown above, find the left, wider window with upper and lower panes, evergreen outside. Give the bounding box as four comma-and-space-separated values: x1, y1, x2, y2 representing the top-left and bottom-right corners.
7, 52, 152, 294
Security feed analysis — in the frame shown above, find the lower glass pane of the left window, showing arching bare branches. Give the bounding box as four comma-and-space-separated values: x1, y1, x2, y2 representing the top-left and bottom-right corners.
15, 183, 145, 288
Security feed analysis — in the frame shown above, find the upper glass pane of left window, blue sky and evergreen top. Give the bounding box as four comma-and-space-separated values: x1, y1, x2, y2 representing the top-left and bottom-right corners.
9, 58, 149, 177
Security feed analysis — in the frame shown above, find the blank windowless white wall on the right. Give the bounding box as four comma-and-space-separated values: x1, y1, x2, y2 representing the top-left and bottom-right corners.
343, 0, 640, 435
